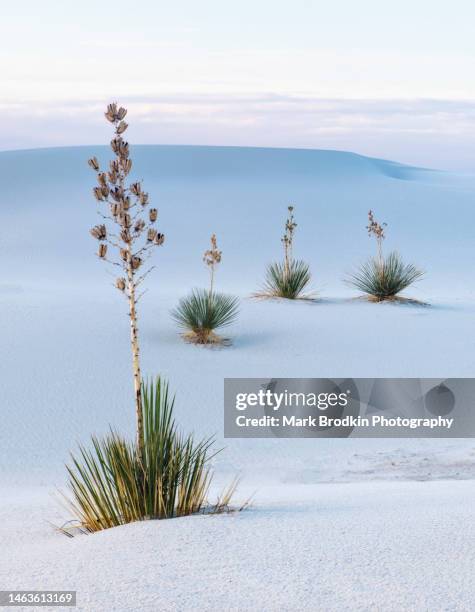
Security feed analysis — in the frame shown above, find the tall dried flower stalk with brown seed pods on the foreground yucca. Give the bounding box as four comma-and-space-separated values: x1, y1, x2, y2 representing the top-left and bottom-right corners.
88, 103, 164, 468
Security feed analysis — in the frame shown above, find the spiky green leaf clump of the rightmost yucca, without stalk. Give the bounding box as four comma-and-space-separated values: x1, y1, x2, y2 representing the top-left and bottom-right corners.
347, 251, 424, 302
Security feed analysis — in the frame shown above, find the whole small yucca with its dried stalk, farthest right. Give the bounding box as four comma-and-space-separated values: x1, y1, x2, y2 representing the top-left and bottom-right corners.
347, 210, 424, 302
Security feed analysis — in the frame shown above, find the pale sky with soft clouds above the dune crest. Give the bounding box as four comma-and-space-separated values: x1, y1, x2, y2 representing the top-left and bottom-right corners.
0, 0, 475, 170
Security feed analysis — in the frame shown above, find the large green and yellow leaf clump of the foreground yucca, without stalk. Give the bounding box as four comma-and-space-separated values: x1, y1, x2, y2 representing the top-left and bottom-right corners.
67, 378, 235, 532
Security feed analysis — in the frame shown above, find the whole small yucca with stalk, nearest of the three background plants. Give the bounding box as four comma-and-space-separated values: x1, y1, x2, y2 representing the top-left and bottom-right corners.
171, 234, 239, 344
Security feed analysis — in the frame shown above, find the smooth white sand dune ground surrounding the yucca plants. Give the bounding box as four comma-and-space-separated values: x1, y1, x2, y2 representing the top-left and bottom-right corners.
0, 146, 475, 611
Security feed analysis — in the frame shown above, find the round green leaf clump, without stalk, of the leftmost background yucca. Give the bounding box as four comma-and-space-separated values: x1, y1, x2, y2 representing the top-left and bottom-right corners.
171, 289, 239, 343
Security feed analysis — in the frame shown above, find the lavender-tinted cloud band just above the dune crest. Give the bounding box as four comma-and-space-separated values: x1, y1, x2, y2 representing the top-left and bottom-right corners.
0, 92, 475, 168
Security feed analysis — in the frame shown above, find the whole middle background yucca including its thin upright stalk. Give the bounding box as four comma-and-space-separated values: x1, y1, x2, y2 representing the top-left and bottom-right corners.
254, 206, 311, 300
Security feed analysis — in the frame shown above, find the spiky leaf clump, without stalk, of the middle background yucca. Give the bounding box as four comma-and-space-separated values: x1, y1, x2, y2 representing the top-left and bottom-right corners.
263, 259, 311, 300
